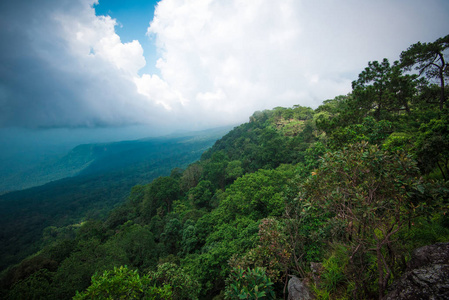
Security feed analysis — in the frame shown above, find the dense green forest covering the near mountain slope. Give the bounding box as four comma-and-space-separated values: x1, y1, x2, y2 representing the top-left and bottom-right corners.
0, 35, 449, 300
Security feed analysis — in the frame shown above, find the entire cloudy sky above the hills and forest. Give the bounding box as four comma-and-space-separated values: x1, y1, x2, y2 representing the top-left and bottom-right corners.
0, 0, 449, 133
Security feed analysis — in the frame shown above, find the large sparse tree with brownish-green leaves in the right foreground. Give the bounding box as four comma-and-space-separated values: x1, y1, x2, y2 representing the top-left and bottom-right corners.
300, 142, 422, 299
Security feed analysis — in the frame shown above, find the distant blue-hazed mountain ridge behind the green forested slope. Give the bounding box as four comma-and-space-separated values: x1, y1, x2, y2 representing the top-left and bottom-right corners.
0, 127, 231, 269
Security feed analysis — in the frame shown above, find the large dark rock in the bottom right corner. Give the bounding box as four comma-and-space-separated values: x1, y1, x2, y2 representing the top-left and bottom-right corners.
384, 243, 449, 300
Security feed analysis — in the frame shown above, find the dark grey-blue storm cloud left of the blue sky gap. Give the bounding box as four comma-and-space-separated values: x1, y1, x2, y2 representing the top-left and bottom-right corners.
0, 0, 165, 127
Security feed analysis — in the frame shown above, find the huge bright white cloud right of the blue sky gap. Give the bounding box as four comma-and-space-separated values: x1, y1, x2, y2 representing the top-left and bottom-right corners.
136, 0, 449, 127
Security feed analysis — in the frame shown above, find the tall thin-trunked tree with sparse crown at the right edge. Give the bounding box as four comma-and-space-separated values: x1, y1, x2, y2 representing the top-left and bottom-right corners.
401, 35, 449, 110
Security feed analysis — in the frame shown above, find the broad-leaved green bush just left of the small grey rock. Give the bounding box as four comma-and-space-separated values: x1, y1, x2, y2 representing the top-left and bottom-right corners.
225, 267, 275, 300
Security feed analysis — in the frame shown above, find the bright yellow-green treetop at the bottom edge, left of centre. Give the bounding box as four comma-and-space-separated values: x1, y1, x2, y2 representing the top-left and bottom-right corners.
73, 266, 172, 300
